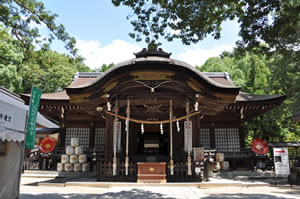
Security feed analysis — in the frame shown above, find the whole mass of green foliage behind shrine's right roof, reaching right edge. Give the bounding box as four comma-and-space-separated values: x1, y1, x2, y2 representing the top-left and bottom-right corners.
197, 49, 300, 146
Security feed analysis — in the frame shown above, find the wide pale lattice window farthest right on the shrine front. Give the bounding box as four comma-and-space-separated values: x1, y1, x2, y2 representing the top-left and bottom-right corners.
215, 128, 240, 152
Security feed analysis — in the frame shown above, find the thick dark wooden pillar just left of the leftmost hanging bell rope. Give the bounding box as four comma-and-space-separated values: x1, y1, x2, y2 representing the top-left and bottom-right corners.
105, 114, 113, 163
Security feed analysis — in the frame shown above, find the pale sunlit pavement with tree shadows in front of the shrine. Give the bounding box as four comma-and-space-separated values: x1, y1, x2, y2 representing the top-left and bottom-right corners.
20, 177, 300, 199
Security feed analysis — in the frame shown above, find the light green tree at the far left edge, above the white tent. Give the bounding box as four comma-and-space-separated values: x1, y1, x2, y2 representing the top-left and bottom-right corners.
0, 26, 26, 92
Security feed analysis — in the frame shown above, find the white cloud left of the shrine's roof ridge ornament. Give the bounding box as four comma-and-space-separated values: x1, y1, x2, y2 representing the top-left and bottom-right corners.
76, 39, 141, 69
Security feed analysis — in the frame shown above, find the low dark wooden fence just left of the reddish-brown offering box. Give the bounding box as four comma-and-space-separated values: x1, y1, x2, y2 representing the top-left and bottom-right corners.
96, 162, 137, 182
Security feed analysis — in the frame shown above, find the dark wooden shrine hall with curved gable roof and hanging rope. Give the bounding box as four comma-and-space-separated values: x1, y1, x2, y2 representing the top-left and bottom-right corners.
22, 49, 285, 181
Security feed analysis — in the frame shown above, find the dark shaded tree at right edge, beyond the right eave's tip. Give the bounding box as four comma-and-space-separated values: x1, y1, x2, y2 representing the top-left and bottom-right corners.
258, 52, 300, 141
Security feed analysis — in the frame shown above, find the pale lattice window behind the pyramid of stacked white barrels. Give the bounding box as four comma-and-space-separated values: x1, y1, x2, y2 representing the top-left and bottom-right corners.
66, 128, 90, 149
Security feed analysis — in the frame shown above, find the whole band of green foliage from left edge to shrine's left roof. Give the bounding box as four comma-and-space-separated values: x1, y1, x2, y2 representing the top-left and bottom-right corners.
0, 26, 91, 93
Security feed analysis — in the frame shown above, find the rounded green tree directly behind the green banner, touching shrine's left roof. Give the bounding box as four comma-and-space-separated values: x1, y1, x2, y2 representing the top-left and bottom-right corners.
22, 50, 91, 93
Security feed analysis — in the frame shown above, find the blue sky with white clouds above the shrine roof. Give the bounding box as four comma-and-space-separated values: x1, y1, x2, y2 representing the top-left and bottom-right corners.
43, 0, 239, 68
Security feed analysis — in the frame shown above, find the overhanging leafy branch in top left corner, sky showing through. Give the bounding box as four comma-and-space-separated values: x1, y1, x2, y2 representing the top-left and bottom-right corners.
0, 0, 77, 55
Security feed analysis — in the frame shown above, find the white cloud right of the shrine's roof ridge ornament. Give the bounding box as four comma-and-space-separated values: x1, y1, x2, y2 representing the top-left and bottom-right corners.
178, 45, 234, 66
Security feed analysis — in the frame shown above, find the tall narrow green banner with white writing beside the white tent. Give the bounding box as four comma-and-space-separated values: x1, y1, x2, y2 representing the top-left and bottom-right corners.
25, 86, 42, 149
